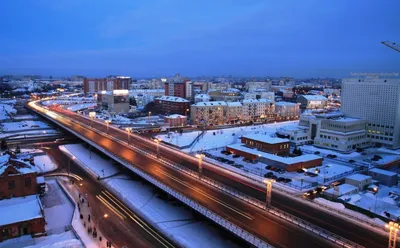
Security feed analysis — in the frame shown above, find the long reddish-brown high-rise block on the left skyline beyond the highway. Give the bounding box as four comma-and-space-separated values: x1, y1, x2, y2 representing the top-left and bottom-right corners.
83, 77, 132, 95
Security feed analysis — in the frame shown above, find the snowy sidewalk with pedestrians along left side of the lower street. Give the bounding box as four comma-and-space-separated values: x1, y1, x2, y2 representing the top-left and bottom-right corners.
59, 179, 114, 248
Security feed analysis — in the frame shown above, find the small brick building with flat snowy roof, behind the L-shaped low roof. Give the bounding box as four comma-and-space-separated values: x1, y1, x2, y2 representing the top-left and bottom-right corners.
241, 134, 290, 155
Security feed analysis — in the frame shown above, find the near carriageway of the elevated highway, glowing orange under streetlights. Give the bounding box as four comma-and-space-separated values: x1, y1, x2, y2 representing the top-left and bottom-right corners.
27, 103, 344, 247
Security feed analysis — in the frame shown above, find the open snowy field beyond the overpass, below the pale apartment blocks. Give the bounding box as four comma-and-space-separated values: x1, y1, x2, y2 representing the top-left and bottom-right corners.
159, 121, 298, 152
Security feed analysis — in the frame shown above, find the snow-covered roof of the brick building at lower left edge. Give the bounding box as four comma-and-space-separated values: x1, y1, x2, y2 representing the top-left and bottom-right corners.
0, 195, 43, 226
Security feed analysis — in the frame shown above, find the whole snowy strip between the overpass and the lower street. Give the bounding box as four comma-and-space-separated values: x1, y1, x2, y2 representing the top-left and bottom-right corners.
62, 145, 241, 248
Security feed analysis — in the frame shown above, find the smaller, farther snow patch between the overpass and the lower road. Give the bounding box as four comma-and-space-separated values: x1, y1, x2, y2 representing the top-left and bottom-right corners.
59, 144, 119, 178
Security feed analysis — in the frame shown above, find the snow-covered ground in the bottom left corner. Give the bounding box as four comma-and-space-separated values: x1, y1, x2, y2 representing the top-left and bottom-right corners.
0, 231, 83, 248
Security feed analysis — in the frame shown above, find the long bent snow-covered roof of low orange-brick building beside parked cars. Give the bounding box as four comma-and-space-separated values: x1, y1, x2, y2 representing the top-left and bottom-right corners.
227, 144, 322, 165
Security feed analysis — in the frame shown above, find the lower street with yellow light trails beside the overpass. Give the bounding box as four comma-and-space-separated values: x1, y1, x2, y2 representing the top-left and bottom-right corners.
46, 144, 177, 248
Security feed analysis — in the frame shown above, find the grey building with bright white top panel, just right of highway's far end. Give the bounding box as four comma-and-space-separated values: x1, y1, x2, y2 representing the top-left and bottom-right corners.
97, 90, 129, 113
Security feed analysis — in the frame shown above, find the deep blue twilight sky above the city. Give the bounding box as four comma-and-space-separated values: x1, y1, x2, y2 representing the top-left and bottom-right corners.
0, 0, 400, 77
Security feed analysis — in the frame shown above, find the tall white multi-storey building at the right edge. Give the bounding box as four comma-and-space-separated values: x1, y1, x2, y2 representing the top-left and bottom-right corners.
341, 73, 400, 148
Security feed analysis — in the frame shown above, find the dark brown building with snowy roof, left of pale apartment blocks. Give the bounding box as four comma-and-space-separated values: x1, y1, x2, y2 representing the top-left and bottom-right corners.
154, 96, 190, 116
